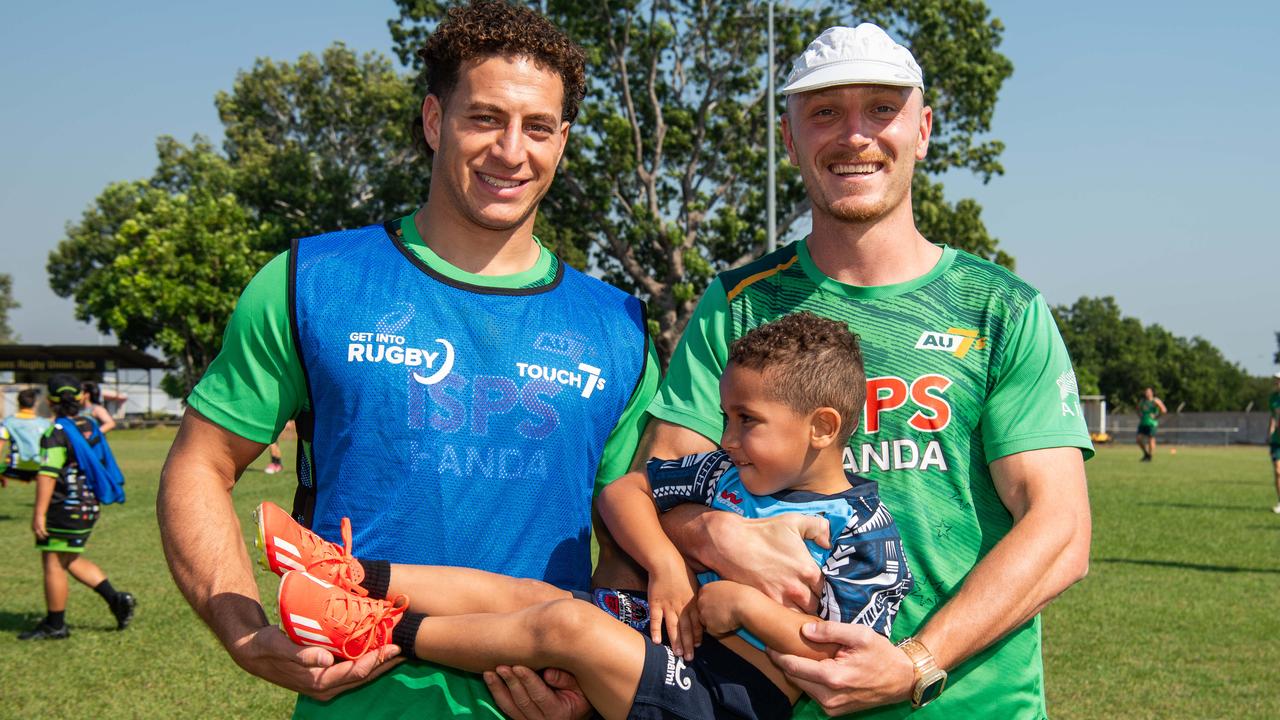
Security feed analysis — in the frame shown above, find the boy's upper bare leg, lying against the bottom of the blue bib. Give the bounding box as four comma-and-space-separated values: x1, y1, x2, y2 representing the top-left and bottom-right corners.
387, 564, 573, 614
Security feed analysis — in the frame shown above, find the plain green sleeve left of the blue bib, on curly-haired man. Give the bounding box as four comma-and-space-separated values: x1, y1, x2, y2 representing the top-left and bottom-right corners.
187, 252, 307, 445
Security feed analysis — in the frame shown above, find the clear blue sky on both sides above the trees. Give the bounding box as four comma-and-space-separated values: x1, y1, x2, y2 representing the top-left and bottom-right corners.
0, 0, 1280, 374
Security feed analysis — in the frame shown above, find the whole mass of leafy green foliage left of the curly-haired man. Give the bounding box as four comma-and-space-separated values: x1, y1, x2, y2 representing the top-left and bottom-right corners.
49, 44, 426, 396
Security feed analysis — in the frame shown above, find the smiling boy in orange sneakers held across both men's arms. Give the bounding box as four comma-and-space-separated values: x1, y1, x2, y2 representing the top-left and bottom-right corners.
259, 313, 911, 719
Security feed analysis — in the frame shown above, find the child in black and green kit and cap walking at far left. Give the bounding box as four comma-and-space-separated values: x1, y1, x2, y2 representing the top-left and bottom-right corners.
18, 375, 136, 641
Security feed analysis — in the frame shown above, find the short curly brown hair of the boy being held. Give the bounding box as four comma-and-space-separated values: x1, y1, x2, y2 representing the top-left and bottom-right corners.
728, 313, 867, 445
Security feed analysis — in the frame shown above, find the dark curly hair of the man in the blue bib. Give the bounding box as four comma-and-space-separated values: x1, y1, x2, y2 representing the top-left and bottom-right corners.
417, 0, 586, 123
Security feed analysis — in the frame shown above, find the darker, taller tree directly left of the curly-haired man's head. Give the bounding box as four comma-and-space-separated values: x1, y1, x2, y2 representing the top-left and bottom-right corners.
215, 42, 429, 242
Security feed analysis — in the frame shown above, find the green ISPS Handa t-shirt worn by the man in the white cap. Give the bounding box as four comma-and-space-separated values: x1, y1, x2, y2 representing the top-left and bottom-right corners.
649, 241, 1093, 717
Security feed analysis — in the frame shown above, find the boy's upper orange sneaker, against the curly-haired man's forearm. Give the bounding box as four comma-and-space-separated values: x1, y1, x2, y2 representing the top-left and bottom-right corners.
253, 502, 369, 594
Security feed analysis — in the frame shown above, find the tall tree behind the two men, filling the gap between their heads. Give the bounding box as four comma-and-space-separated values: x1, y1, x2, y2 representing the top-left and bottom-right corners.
388, 0, 1012, 357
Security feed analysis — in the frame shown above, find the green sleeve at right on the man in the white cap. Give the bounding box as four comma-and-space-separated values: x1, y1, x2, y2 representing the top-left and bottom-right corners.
982, 296, 1093, 462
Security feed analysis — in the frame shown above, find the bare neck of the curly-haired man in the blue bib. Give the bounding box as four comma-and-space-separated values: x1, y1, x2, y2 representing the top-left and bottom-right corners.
413, 200, 541, 275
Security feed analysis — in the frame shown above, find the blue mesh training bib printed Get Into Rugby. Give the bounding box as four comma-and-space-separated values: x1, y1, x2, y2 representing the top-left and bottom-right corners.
291, 225, 646, 589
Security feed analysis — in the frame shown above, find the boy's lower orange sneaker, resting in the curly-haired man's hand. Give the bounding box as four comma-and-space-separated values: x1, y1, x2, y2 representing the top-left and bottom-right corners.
279, 570, 408, 660
